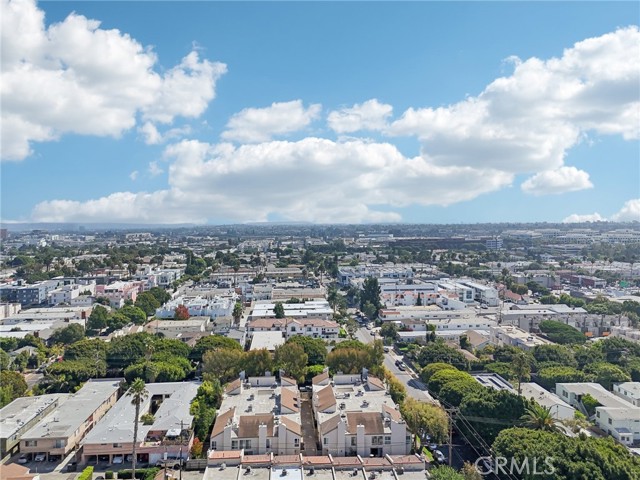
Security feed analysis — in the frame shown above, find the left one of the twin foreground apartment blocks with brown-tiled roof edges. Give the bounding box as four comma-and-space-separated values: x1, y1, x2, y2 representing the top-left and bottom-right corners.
211, 375, 303, 455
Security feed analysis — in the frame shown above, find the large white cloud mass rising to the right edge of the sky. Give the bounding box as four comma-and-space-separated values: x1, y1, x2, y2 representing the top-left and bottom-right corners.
387, 26, 640, 173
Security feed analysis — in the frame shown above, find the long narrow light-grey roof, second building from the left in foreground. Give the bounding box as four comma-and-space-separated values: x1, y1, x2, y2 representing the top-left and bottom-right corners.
22, 379, 120, 440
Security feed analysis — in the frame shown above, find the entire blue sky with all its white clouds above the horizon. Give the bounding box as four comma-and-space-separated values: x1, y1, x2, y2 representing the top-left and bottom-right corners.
0, 0, 640, 223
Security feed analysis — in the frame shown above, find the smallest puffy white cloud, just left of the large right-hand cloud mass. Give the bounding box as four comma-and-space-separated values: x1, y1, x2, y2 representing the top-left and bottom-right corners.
327, 98, 393, 133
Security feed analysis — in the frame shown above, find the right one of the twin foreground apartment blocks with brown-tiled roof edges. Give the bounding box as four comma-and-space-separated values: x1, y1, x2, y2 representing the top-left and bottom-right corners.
312, 372, 411, 457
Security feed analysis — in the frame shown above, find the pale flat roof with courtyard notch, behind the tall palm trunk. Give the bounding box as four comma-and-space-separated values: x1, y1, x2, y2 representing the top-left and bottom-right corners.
82, 382, 200, 445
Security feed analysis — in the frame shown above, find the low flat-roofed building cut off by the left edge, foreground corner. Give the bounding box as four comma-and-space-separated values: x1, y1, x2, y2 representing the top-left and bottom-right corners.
0, 393, 71, 458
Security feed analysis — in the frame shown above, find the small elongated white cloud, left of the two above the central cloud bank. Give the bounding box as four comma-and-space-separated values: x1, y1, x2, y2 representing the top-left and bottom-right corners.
222, 100, 322, 143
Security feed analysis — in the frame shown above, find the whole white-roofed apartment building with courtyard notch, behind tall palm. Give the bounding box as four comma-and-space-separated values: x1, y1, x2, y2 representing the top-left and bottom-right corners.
81, 382, 200, 463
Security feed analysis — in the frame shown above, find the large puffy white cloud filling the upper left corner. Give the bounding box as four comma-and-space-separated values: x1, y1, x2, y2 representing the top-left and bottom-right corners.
0, 0, 226, 160
